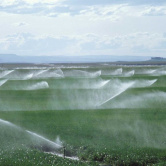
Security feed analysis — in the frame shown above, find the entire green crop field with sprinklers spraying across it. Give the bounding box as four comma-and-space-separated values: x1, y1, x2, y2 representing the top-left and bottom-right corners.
0, 64, 166, 166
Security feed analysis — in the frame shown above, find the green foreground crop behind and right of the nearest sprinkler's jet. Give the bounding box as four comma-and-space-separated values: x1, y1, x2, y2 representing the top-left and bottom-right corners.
0, 109, 166, 165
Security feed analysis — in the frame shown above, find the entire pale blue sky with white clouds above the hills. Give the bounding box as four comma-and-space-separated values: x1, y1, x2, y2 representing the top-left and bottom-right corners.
0, 0, 166, 57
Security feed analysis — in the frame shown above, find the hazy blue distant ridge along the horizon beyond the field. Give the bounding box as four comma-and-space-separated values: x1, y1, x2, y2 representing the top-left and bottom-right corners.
0, 54, 150, 63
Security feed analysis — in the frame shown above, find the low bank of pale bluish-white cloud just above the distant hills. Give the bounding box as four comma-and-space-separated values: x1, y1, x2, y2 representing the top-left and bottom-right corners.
0, 32, 166, 56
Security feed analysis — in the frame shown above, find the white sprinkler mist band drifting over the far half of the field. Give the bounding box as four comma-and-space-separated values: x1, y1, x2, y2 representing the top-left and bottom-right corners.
0, 65, 166, 111
